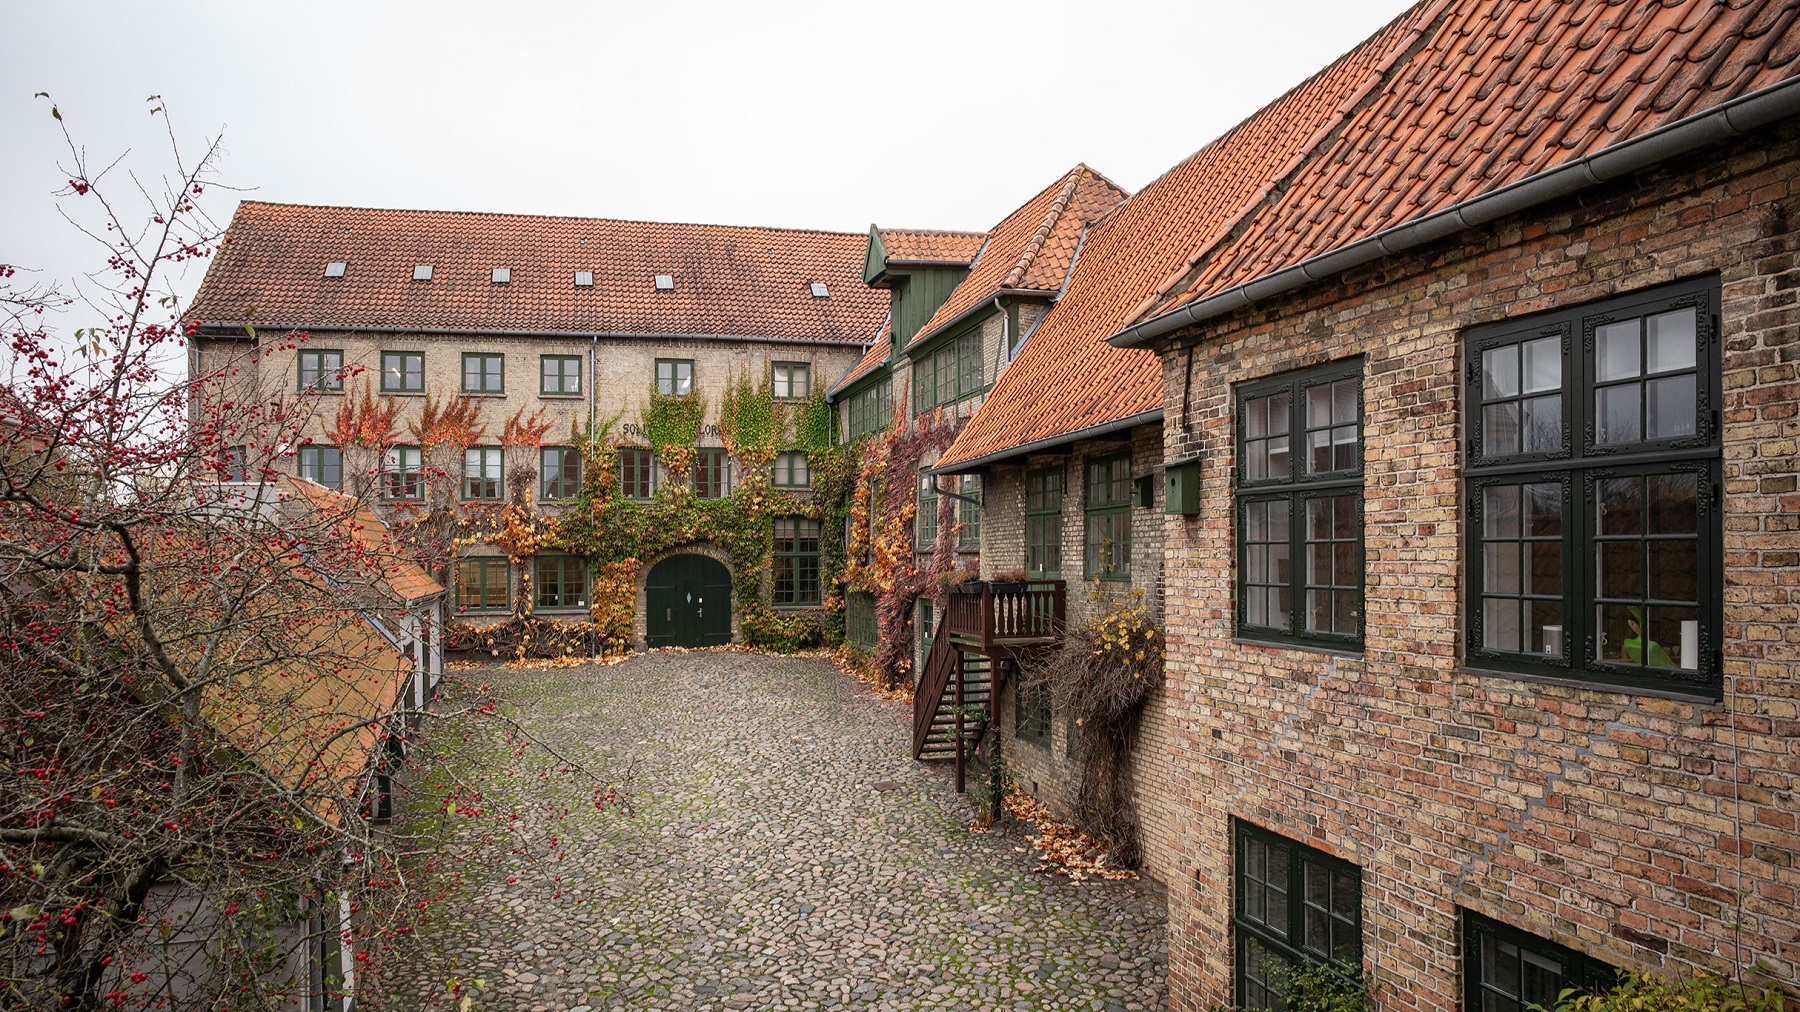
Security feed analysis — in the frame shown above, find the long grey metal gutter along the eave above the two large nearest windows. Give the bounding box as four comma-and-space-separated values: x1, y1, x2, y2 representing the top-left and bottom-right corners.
1107, 77, 1800, 348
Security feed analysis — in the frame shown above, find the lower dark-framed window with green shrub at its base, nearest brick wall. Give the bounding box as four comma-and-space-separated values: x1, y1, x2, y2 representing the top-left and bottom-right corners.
1231, 821, 1363, 1012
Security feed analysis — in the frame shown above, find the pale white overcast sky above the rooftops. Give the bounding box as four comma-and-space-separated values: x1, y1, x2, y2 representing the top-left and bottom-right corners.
0, 0, 1406, 328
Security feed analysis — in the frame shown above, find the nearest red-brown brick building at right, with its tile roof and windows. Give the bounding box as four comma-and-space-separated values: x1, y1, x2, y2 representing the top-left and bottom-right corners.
1101, 0, 1800, 1010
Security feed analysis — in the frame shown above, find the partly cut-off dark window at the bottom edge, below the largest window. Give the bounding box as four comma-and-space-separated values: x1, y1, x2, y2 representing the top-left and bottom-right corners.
1463, 909, 1618, 1012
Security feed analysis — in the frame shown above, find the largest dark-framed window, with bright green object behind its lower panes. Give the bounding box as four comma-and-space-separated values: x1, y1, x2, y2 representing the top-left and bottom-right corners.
1465, 277, 1724, 697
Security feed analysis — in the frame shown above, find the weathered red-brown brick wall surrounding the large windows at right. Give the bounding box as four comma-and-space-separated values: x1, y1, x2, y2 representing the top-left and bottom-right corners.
1156, 117, 1800, 1012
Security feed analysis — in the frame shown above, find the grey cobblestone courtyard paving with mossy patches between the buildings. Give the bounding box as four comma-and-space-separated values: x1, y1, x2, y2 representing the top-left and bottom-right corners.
396, 652, 1166, 1012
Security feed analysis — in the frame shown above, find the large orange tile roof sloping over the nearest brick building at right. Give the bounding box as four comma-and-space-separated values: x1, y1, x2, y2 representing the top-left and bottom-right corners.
938, 0, 1800, 468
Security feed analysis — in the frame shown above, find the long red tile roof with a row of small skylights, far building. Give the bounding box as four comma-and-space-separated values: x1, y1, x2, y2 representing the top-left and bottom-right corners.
189, 200, 887, 344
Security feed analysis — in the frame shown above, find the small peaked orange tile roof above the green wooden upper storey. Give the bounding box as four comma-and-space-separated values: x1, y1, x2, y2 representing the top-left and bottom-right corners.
907, 166, 1130, 348
